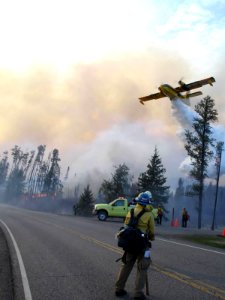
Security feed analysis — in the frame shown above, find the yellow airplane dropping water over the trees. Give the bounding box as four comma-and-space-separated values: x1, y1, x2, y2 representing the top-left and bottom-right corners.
139, 77, 216, 105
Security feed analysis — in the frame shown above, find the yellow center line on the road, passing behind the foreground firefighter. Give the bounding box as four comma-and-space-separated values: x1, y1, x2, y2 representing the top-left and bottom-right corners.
28, 217, 225, 300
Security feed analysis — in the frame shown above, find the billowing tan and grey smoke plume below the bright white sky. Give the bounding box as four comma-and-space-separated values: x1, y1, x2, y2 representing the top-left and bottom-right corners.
0, 56, 224, 195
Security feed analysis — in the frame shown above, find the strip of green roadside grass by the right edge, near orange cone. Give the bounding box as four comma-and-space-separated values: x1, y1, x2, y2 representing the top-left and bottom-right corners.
182, 235, 225, 249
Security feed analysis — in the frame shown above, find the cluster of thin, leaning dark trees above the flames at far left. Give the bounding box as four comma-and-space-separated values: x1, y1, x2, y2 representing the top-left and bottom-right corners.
0, 145, 63, 202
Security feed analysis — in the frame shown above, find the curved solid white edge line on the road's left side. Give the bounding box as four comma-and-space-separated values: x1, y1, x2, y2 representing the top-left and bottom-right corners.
0, 220, 32, 300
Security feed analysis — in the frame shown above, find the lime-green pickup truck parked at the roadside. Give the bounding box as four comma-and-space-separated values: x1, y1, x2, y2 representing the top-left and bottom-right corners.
93, 197, 157, 221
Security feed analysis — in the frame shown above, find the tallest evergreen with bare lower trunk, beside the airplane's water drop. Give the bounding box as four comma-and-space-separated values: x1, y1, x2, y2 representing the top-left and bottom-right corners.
185, 96, 217, 229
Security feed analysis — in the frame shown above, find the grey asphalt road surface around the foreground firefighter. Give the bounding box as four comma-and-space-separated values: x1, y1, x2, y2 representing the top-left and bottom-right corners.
0, 205, 225, 300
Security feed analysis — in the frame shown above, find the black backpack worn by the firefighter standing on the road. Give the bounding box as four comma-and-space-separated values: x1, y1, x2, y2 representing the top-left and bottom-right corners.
117, 208, 147, 254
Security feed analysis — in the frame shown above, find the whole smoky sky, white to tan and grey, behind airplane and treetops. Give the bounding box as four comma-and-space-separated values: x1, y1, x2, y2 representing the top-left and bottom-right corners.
0, 0, 225, 192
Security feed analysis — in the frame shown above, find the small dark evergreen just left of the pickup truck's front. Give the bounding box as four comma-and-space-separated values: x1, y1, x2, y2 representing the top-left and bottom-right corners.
78, 184, 94, 216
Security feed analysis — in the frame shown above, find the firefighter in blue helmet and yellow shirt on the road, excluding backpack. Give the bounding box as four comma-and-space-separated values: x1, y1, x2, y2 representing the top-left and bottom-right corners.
115, 191, 155, 300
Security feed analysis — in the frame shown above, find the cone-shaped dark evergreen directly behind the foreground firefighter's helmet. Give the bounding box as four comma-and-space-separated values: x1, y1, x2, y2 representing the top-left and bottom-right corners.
138, 147, 170, 209
